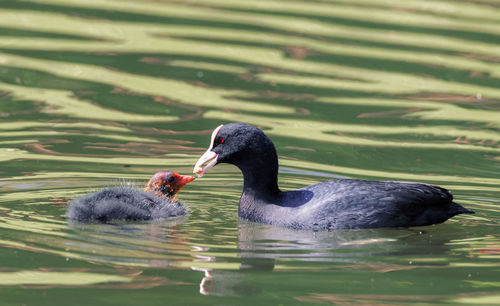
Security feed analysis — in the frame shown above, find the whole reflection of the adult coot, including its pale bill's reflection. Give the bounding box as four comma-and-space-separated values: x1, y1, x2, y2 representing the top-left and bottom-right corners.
191, 221, 467, 296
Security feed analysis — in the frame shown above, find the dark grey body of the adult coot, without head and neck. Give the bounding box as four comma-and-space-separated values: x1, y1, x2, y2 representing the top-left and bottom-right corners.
239, 180, 472, 230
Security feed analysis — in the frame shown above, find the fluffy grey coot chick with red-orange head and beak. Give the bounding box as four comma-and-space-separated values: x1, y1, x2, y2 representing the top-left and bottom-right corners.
66, 171, 194, 223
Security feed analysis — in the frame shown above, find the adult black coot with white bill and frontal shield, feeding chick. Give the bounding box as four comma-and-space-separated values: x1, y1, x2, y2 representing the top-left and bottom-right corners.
193, 123, 474, 230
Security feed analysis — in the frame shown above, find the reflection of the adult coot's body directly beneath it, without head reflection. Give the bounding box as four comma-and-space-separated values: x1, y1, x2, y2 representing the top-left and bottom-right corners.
238, 220, 468, 260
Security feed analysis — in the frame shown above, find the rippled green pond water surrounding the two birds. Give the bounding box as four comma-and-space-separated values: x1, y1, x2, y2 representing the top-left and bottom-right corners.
0, 0, 500, 305
